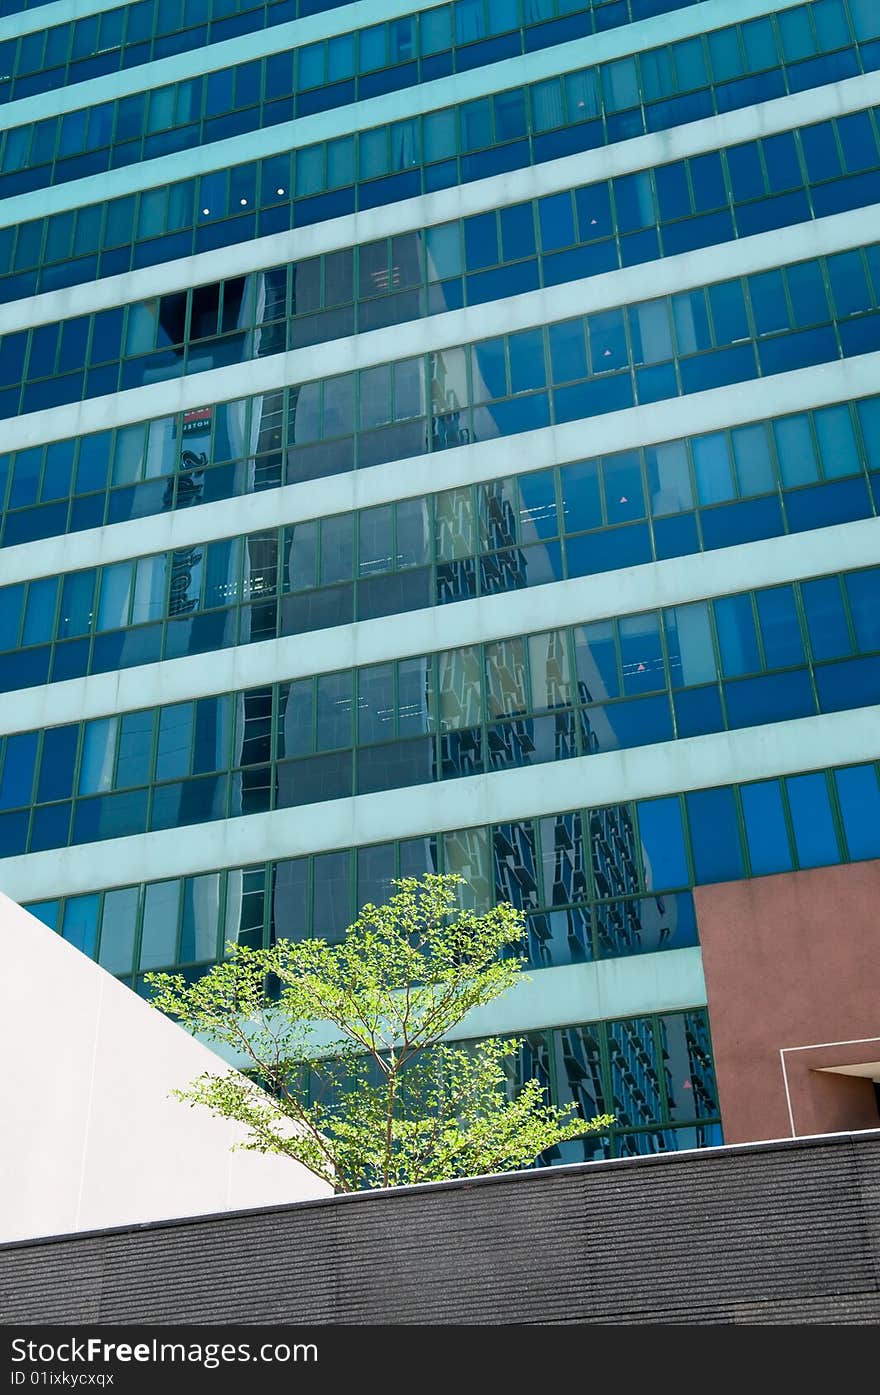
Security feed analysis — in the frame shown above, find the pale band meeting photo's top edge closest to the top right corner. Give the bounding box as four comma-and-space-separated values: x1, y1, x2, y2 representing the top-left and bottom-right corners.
0, 0, 820, 226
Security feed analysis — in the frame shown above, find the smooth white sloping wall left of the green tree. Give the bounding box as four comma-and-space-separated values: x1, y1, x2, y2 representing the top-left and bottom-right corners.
0, 896, 331, 1243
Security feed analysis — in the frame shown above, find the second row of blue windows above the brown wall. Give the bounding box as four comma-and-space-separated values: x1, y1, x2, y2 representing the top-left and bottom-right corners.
0, 568, 880, 855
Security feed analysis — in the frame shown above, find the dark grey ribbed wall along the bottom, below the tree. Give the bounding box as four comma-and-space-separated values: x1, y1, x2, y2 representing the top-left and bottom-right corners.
0, 1131, 880, 1324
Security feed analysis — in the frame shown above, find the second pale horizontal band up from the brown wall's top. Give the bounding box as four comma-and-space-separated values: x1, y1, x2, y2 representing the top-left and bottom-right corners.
0, 519, 880, 734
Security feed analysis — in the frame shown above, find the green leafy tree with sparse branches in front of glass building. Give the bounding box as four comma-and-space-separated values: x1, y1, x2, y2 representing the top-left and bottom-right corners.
148, 875, 614, 1191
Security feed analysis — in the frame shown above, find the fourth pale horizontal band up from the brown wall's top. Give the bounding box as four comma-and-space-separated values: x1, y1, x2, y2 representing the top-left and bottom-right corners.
3, 206, 877, 451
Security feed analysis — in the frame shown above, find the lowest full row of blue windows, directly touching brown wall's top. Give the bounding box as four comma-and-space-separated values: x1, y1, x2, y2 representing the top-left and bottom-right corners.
28, 763, 880, 983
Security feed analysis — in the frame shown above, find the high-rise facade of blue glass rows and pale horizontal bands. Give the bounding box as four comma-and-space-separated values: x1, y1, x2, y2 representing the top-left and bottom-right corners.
0, 0, 880, 1161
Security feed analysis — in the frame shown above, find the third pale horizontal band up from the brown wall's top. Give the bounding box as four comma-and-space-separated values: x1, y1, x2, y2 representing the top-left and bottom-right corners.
0, 353, 880, 586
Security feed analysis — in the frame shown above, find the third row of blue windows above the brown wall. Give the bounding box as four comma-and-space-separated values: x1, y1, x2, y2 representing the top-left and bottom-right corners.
0, 398, 880, 691
